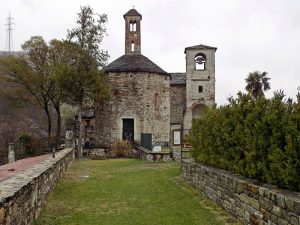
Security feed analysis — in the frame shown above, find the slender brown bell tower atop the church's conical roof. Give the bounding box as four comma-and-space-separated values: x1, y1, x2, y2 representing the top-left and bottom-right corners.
124, 9, 142, 55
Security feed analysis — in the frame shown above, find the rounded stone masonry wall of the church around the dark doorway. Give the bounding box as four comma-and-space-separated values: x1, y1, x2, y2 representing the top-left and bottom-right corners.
95, 72, 170, 146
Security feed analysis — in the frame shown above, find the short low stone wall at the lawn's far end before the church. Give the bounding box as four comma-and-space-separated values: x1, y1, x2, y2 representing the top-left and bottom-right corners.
134, 146, 173, 162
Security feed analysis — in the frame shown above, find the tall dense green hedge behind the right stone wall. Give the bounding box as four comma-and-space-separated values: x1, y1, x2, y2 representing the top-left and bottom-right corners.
189, 92, 300, 191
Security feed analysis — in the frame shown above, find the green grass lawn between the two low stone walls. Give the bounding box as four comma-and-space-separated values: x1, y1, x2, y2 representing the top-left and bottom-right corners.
34, 159, 240, 225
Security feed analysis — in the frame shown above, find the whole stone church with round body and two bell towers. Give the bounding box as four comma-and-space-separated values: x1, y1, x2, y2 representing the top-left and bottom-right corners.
94, 9, 217, 151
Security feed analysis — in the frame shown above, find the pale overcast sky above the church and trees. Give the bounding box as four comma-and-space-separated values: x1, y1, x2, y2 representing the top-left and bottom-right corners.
0, 0, 300, 104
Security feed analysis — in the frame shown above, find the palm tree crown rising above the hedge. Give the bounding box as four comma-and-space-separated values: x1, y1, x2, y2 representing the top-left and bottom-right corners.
245, 71, 271, 99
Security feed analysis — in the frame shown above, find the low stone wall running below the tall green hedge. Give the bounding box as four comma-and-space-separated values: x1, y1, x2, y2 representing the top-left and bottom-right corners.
181, 159, 300, 225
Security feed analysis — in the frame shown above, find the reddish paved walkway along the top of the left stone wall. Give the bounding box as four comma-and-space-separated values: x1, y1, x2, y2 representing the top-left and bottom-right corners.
0, 154, 52, 182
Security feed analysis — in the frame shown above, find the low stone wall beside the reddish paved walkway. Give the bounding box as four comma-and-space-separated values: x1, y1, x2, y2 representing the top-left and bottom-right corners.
0, 148, 74, 225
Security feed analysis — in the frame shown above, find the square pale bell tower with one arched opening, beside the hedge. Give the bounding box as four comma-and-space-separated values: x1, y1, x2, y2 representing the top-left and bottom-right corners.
183, 45, 217, 135
